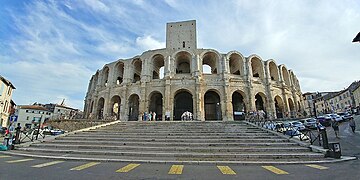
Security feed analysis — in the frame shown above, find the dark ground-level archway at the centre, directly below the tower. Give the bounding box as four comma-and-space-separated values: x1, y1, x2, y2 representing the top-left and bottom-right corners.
174, 90, 193, 120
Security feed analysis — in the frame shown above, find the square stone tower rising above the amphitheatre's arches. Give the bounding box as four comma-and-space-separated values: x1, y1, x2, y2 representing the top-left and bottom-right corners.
166, 20, 197, 50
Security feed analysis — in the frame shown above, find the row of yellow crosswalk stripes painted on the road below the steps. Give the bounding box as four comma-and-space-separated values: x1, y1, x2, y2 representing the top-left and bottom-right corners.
0, 155, 329, 175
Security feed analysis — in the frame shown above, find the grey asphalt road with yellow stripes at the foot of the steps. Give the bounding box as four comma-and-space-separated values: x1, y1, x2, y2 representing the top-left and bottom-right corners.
0, 116, 360, 180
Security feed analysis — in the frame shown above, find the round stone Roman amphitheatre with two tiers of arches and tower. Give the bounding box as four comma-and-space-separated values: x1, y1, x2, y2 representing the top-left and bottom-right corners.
84, 21, 304, 121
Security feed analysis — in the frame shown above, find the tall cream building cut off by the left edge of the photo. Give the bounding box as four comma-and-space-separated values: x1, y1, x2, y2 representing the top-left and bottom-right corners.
0, 76, 16, 127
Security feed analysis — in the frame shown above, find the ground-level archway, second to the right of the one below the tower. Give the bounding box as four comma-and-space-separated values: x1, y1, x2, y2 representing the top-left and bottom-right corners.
231, 91, 246, 120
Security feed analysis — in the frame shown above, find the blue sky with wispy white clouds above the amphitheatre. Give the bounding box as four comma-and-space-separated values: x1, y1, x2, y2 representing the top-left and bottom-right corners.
0, 0, 360, 109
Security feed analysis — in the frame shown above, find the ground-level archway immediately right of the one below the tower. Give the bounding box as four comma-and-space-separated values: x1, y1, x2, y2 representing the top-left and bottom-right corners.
204, 91, 222, 121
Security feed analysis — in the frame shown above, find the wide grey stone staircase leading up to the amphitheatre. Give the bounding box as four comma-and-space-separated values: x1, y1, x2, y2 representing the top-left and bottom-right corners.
14, 122, 324, 164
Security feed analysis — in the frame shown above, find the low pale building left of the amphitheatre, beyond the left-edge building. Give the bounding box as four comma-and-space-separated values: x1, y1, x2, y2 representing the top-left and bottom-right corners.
15, 105, 52, 127
